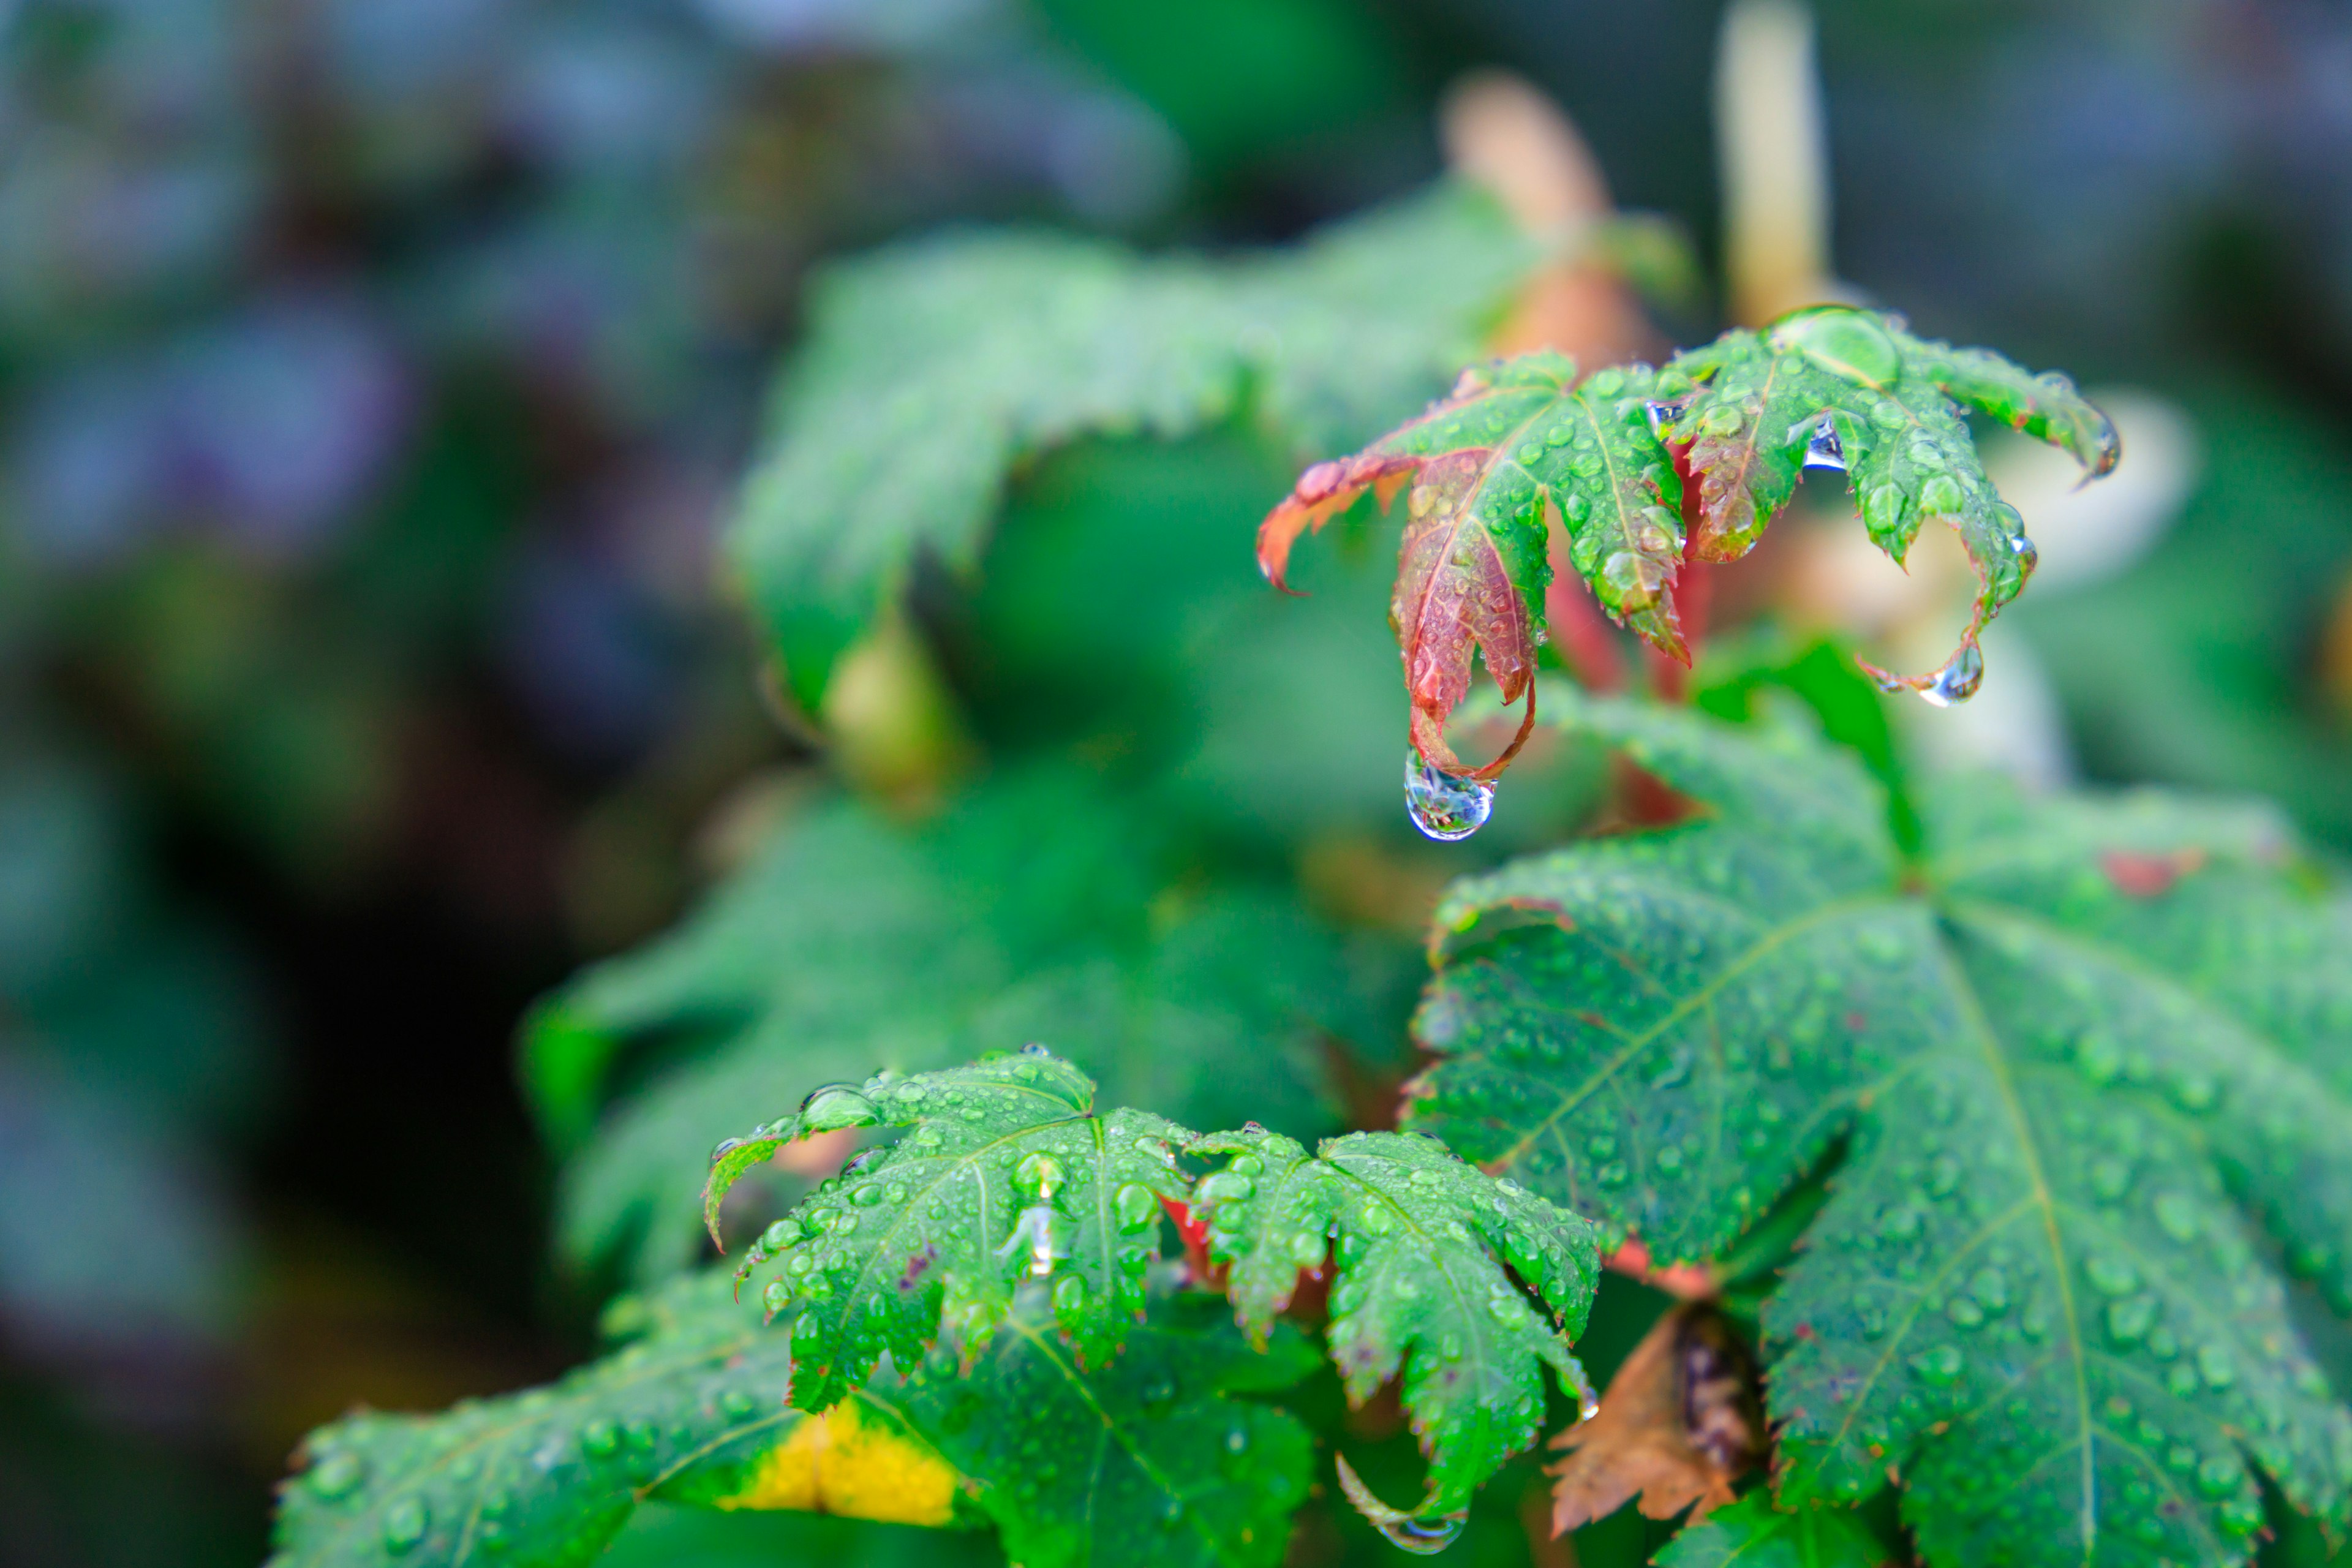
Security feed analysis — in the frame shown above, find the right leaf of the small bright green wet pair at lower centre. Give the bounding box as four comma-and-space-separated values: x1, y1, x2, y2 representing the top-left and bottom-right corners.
1193, 1131, 1599, 1514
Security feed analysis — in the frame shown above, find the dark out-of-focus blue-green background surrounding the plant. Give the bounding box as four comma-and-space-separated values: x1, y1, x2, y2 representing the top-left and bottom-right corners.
0, 0, 2352, 1568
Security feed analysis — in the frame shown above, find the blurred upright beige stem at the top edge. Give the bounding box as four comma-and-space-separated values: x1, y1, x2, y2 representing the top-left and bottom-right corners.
1714, 0, 1856, 326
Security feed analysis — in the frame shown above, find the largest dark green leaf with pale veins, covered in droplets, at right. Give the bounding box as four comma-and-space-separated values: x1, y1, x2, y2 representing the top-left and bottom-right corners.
1409, 693, 2352, 1566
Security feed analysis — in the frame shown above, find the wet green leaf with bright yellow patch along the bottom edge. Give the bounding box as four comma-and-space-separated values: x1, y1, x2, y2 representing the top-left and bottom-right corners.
271, 1276, 1313, 1568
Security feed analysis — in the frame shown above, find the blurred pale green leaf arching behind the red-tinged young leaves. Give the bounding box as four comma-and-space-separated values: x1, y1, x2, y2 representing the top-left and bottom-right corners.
729, 188, 1540, 712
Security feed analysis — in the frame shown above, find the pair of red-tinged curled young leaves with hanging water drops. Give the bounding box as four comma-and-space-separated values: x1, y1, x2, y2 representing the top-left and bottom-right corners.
1258, 306, 2119, 778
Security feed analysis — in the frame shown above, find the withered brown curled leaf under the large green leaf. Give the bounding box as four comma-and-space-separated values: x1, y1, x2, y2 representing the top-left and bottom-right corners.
1552, 1305, 1764, 1535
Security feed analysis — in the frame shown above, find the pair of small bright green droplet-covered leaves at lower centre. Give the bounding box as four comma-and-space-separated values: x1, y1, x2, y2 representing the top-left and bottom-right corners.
703, 1046, 1597, 1507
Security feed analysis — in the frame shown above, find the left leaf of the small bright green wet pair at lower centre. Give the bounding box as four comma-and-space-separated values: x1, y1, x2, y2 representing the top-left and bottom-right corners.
703, 1046, 1193, 1411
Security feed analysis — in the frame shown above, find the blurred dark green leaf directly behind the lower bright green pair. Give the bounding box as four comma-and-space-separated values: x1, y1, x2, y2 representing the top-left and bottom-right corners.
524, 771, 1404, 1279
